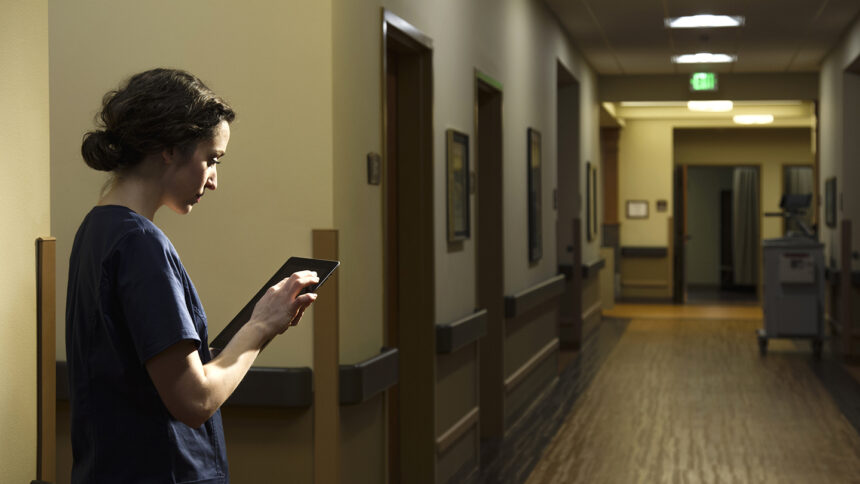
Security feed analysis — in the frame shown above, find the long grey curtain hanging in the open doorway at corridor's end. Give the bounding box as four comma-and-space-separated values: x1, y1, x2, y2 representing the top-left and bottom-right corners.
732, 168, 760, 286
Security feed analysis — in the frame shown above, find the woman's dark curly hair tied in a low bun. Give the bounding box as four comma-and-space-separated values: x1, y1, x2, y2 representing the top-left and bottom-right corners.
81, 69, 236, 171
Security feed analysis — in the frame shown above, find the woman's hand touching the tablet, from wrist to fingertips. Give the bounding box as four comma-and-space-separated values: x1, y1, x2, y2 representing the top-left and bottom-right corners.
251, 271, 320, 339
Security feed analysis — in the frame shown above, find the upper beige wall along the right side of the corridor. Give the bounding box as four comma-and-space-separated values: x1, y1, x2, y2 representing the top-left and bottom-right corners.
819, 15, 860, 270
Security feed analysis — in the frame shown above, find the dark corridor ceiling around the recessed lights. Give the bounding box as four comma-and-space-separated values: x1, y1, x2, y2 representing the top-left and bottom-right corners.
544, 0, 860, 75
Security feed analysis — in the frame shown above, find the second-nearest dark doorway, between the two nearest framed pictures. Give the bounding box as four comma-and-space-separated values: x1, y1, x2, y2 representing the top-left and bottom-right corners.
475, 72, 505, 441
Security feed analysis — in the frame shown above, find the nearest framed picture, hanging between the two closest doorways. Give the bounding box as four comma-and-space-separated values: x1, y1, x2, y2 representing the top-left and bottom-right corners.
445, 129, 471, 242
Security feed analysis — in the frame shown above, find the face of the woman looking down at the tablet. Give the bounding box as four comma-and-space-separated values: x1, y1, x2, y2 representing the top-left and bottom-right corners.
162, 121, 230, 214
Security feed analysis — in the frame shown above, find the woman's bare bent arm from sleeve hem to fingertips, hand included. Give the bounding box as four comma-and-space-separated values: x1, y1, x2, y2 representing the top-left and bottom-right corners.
146, 271, 319, 428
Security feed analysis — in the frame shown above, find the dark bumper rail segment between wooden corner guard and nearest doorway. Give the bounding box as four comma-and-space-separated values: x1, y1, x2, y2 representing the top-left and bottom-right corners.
340, 348, 400, 405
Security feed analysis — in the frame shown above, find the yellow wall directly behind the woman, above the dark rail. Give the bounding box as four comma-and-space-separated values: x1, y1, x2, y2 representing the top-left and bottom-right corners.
50, 0, 334, 366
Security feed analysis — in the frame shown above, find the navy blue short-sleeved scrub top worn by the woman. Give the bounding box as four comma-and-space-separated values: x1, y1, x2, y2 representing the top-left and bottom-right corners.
66, 206, 229, 484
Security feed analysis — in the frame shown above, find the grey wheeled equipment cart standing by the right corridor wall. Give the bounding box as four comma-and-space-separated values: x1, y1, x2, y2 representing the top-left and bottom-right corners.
757, 237, 824, 359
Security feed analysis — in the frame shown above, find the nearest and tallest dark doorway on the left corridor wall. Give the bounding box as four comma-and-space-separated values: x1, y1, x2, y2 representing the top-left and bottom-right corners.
382, 10, 436, 483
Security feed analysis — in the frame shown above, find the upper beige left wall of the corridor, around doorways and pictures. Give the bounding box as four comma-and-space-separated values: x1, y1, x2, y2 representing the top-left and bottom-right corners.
333, 0, 599, 362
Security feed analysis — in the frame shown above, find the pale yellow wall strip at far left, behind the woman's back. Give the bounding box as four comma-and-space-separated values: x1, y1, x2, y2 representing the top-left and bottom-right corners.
0, 0, 51, 482
